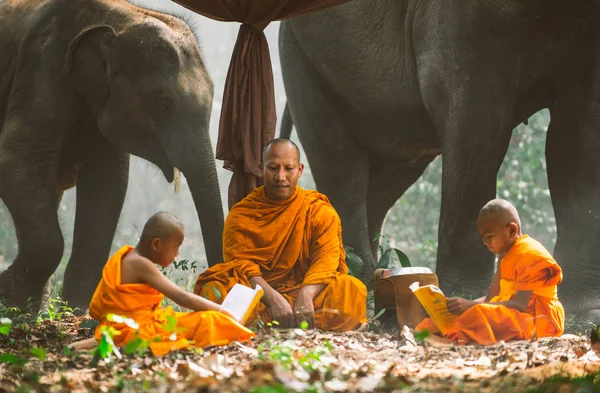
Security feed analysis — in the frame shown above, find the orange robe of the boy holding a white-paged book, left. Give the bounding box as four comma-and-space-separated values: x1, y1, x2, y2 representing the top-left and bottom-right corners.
90, 246, 254, 355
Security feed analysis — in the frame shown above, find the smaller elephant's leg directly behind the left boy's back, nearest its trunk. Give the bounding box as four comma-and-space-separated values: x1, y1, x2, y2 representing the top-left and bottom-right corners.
63, 141, 129, 311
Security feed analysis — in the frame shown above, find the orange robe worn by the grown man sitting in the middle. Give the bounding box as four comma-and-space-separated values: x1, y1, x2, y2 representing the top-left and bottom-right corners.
194, 187, 367, 331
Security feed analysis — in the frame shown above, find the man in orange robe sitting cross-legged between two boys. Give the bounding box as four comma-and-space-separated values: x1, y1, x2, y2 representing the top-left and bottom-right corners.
194, 139, 367, 331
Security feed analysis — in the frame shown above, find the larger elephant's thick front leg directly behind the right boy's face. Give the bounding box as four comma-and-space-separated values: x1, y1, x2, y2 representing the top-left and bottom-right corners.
421, 70, 514, 297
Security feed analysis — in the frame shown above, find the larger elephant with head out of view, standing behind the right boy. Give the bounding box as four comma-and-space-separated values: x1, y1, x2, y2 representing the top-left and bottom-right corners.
280, 0, 600, 320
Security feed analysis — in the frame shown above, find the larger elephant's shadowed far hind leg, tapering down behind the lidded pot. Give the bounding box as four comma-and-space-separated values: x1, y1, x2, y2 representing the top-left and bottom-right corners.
367, 156, 435, 260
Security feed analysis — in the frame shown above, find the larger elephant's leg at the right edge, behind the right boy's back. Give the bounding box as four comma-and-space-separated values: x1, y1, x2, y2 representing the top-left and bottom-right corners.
546, 81, 600, 324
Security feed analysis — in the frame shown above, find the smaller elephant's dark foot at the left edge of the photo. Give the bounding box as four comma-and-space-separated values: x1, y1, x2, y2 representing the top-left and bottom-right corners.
0, 263, 48, 315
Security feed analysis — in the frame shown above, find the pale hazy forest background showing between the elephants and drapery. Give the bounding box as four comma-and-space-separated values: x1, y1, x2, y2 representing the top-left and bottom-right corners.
0, 0, 556, 288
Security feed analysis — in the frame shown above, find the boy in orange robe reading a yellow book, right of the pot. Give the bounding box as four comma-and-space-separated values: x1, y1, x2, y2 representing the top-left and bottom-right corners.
416, 199, 565, 345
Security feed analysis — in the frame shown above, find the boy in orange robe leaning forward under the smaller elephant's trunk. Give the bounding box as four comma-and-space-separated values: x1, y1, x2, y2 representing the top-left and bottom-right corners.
90, 212, 254, 355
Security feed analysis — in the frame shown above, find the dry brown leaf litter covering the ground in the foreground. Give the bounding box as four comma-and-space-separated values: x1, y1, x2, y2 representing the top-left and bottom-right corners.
0, 317, 600, 393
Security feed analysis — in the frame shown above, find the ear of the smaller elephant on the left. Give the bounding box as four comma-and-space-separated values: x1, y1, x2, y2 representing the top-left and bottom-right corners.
62, 25, 118, 113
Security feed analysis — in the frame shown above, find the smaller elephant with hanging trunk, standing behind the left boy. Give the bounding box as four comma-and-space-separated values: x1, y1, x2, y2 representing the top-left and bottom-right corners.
0, 0, 223, 311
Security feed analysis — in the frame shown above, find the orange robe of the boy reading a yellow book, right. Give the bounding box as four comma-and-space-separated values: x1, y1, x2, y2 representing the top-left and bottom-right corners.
416, 235, 565, 345
